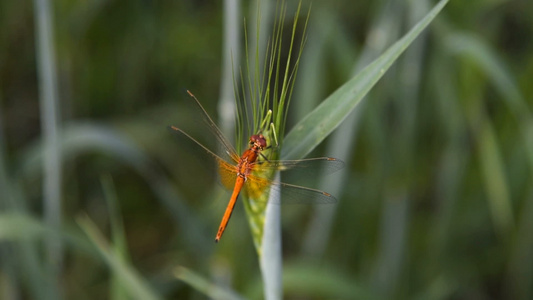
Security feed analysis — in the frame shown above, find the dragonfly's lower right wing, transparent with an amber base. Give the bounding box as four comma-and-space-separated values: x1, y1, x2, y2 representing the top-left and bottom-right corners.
245, 175, 337, 204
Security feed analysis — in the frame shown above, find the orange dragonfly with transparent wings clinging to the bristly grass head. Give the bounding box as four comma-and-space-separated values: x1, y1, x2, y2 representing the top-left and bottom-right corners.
170, 91, 344, 243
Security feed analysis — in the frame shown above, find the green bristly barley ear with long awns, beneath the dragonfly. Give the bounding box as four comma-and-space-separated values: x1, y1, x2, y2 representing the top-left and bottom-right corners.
234, 1, 309, 256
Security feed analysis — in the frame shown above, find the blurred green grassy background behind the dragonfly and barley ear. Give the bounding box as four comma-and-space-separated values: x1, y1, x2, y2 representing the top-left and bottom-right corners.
0, 0, 533, 299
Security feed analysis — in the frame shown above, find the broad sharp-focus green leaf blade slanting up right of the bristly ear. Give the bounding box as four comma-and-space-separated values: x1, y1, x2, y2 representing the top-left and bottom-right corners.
281, 0, 448, 159
